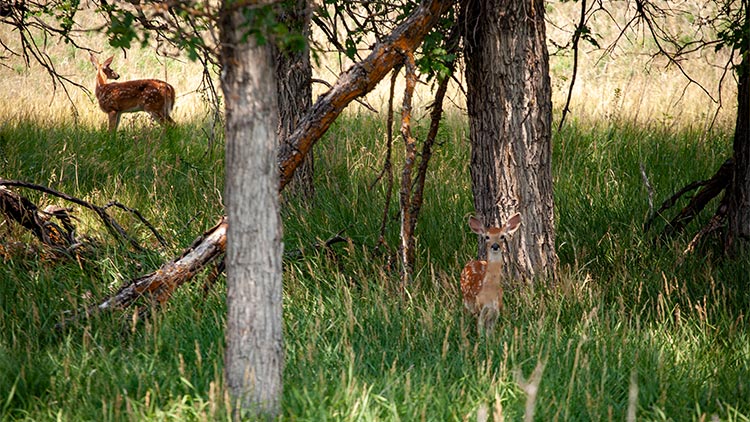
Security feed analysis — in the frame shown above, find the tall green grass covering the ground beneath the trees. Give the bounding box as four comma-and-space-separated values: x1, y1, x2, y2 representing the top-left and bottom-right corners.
0, 115, 750, 421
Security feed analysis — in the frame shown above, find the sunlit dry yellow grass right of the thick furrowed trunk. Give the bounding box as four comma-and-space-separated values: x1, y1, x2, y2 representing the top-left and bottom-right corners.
547, 2, 737, 130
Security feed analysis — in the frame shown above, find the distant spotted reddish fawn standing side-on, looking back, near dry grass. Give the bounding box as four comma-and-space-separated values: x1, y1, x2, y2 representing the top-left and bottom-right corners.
91, 53, 174, 132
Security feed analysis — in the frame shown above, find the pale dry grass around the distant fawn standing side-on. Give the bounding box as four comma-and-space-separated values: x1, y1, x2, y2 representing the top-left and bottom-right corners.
0, 8, 206, 127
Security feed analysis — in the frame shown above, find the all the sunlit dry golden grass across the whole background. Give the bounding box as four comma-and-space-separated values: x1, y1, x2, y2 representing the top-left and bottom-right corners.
0, 2, 736, 129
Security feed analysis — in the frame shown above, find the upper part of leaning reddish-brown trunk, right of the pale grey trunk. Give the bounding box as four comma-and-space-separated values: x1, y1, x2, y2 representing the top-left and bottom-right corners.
279, 0, 453, 189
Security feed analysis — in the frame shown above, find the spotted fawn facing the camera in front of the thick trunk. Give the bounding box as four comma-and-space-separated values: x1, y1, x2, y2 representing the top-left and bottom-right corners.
461, 213, 521, 334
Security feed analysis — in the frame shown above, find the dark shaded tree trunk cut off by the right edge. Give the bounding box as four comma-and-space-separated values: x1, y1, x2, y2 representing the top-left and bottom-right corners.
726, 38, 750, 251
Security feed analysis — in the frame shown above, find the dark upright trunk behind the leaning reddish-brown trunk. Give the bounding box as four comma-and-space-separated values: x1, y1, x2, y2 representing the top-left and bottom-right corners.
274, 0, 314, 200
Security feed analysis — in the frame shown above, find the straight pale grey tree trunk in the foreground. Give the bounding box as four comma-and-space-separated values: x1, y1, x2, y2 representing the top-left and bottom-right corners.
221, 3, 283, 419
